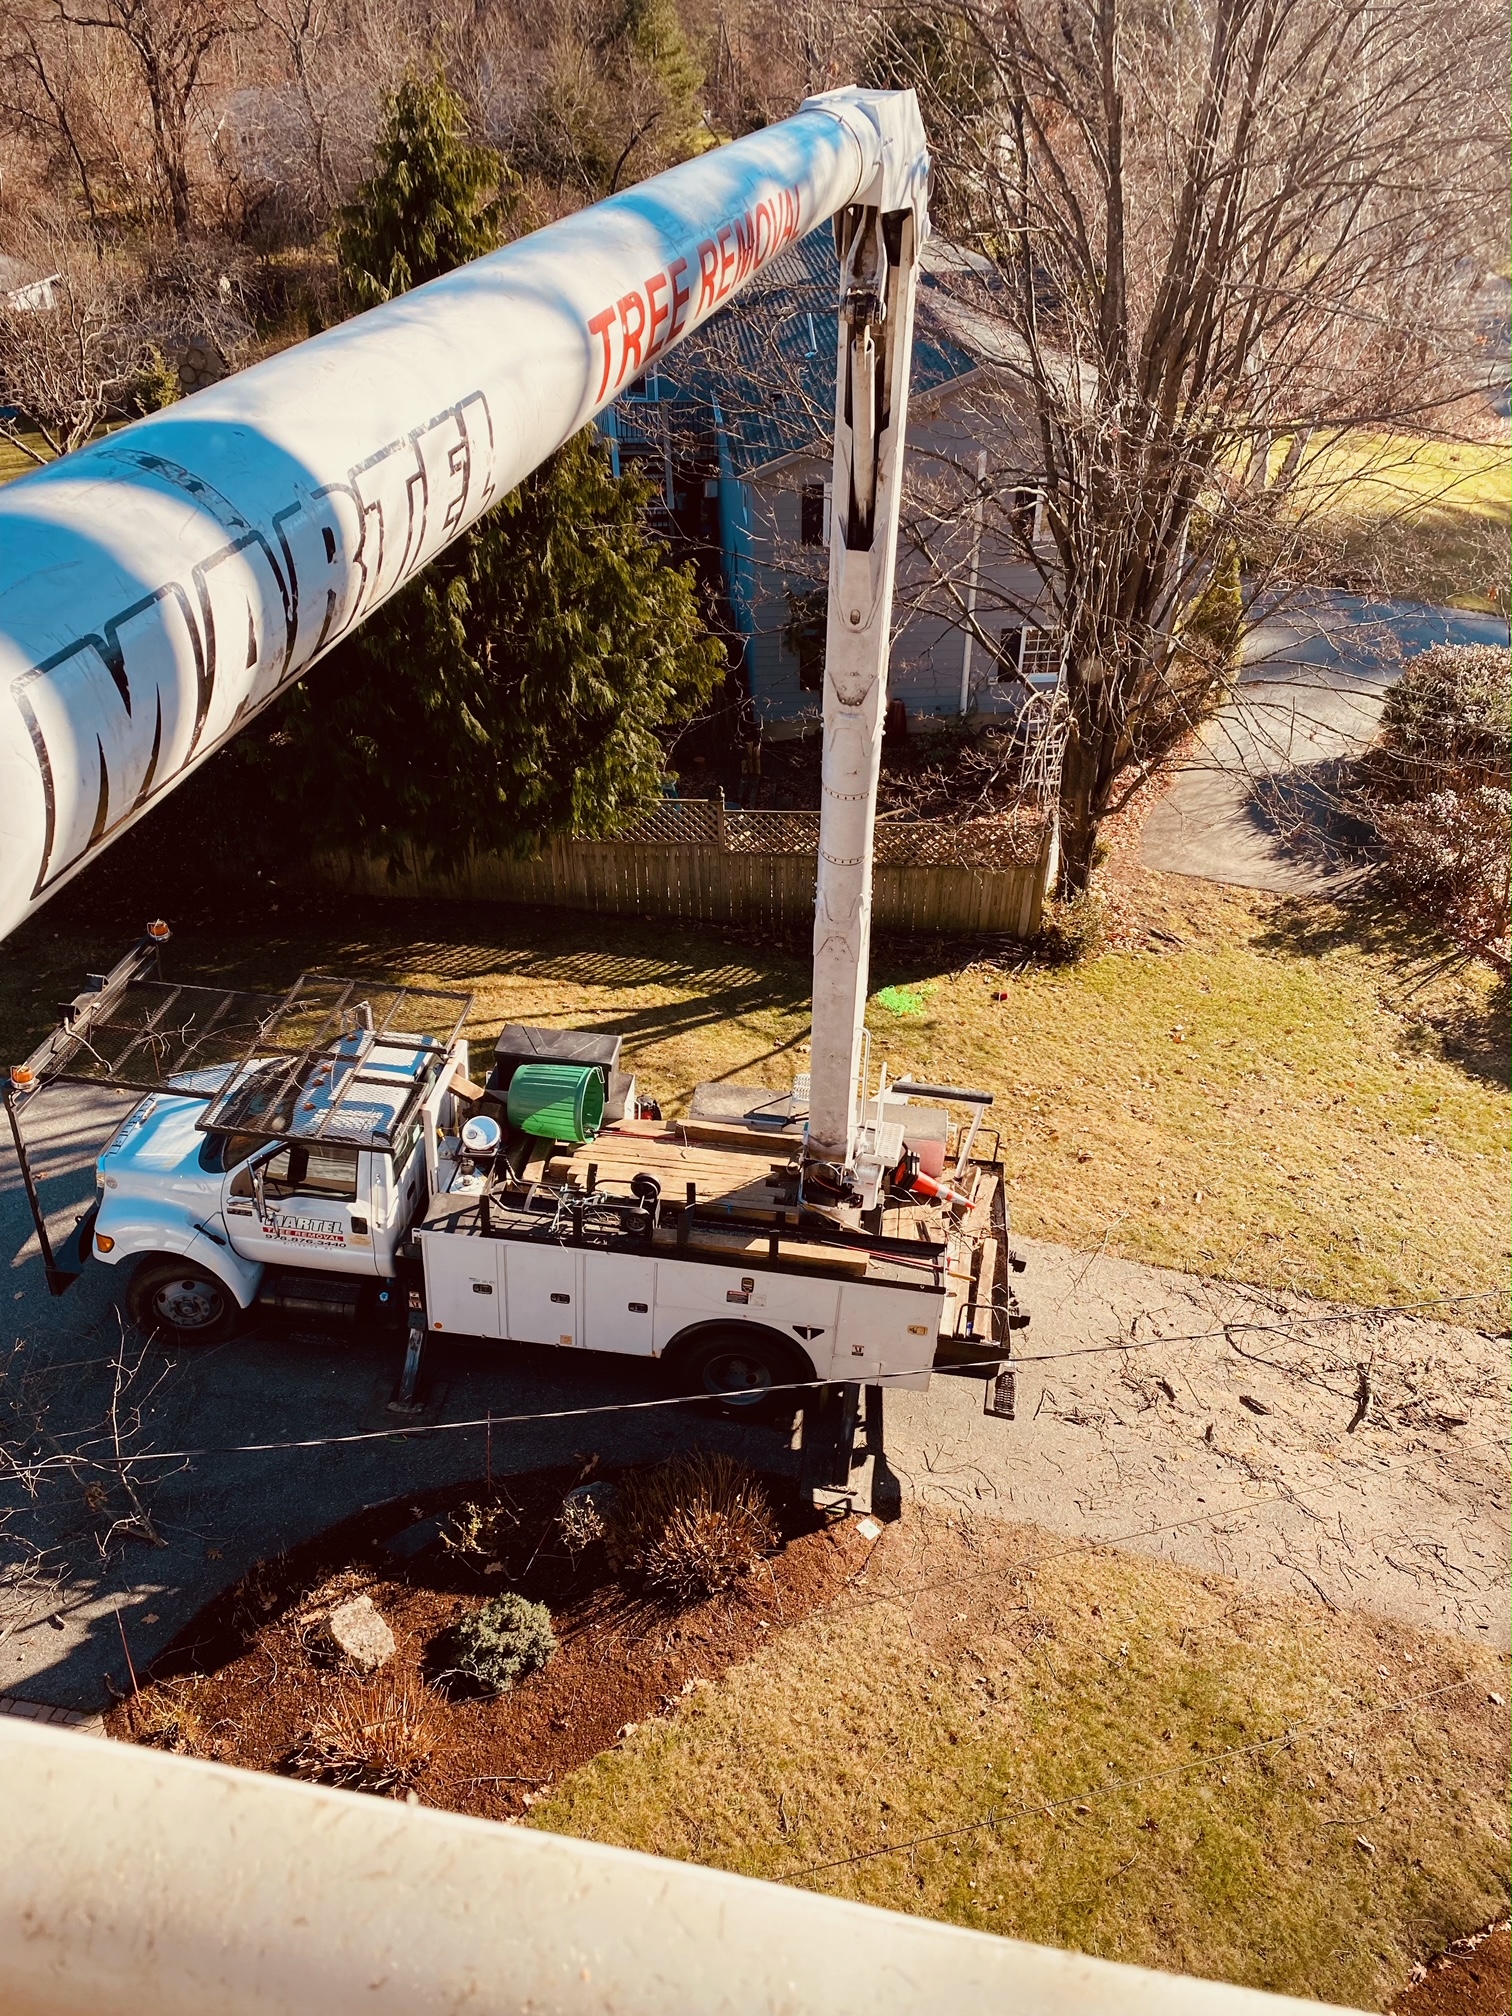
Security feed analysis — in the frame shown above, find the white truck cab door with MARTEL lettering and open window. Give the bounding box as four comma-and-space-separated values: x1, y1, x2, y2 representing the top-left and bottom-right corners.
224, 1141, 377, 1274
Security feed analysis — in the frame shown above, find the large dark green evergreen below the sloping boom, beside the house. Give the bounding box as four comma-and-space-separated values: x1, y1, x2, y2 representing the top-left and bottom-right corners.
272, 429, 724, 865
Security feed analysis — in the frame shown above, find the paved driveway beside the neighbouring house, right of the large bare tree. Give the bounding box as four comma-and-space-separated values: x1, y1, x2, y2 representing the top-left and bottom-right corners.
1143, 595, 1508, 895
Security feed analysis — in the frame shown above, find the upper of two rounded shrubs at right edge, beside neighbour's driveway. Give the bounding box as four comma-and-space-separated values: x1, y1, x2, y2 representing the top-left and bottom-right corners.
1371, 645, 1512, 796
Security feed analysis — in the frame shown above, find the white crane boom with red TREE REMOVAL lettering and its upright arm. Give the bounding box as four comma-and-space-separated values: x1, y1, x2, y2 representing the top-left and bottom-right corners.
0, 89, 929, 1163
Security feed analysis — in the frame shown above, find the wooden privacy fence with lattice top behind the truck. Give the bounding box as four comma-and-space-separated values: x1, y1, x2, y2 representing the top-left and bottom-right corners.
317, 798, 1056, 937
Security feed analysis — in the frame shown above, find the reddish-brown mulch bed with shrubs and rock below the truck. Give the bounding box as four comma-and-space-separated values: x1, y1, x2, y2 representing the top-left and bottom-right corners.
107, 1466, 871, 1820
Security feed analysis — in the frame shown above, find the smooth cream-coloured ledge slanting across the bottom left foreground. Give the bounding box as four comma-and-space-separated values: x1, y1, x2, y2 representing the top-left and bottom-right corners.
0, 1718, 1370, 2016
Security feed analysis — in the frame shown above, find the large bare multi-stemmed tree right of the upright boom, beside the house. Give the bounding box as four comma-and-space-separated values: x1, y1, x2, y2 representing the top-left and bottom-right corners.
895, 0, 1508, 891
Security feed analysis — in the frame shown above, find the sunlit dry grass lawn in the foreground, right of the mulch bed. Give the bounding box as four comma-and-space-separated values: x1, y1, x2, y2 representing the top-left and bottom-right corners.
530, 1514, 1512, 2008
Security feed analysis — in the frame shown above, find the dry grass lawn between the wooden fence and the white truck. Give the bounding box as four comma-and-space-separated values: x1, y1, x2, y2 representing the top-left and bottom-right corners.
0, 877, 1512, 1329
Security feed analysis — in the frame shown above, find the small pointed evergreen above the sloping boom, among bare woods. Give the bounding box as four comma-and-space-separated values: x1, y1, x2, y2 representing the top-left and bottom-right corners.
337, 67, 518, 308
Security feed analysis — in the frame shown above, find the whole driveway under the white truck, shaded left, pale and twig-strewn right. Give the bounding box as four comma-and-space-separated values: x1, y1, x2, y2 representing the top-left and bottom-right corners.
0, 1093, 1512, 1710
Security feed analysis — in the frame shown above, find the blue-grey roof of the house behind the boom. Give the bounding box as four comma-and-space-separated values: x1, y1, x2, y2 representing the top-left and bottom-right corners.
615, 232, 996, 476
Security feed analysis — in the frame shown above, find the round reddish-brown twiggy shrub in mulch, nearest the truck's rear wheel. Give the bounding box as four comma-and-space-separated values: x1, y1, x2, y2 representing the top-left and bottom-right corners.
607, 1452, 778, 1603
